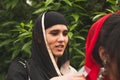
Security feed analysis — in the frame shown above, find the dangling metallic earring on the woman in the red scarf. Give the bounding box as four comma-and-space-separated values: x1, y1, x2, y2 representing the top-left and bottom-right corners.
97, 60, 107, 80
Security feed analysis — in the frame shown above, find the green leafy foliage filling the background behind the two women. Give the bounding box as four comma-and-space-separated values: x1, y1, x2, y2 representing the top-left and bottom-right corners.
0, 0, 120, 80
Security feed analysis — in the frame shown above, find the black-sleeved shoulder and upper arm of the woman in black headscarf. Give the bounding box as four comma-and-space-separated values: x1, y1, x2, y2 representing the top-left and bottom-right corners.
6, 60, 28, 80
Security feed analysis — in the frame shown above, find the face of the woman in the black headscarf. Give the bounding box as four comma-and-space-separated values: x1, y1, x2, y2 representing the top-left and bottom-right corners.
46, 24, 68, 57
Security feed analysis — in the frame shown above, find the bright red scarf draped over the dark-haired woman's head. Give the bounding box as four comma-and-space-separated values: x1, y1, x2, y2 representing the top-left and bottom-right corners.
85, 14, 112, 80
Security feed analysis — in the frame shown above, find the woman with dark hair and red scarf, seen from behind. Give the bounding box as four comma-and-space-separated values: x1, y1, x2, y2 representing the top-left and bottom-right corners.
85, 12, 120, 80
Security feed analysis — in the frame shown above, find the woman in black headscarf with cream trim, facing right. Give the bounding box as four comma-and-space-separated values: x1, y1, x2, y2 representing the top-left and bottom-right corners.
7, 11, 85, 80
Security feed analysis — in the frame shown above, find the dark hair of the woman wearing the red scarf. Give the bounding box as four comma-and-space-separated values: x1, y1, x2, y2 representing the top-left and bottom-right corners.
93, 14, 120, 74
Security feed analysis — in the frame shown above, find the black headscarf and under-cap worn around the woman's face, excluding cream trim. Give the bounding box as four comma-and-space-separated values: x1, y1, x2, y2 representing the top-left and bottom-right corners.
29, 11, 69, 80
